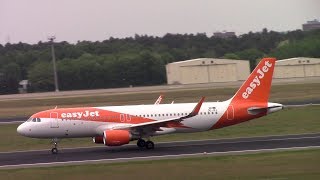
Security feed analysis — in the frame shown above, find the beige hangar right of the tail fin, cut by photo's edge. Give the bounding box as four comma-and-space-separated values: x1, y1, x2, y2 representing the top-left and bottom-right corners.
273, 57, 320, 79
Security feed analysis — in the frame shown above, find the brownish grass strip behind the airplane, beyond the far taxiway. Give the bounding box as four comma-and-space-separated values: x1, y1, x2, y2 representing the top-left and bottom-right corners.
0, 83, 320, 118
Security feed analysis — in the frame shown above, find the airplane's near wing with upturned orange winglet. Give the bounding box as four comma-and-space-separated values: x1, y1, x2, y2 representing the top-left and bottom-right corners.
112, 97, 205, 129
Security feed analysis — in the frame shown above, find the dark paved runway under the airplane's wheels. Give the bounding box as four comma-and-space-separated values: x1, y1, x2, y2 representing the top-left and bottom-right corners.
0, 133, 320, 168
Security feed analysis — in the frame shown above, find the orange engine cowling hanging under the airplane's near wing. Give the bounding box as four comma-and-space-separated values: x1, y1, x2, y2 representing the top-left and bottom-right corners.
103, 130, 131, 146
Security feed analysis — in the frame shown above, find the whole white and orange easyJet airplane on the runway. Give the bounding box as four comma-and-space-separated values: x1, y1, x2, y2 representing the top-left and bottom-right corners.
17, 58, 283, 154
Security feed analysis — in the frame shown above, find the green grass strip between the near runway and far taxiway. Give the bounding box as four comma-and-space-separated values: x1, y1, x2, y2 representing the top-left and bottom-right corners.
0, 106, 320, 151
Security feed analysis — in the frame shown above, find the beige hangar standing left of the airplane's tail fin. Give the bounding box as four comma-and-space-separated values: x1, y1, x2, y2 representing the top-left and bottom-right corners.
166, 58, 250, 84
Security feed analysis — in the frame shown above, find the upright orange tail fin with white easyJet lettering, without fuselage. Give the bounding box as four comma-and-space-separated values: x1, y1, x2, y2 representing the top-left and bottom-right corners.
232, 58, 276, 103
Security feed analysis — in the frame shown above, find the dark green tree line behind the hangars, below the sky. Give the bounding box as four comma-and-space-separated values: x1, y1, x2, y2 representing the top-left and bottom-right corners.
0, 29, 320, 94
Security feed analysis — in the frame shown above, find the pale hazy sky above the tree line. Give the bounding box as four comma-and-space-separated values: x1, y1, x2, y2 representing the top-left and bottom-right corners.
0, 0, 320, 44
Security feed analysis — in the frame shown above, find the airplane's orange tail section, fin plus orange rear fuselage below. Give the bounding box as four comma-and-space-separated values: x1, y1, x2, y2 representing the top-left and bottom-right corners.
211, 58, 276, 129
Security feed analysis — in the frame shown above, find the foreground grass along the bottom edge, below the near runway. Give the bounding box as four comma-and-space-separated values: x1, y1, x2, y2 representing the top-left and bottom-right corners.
0, 149, 320, 180
